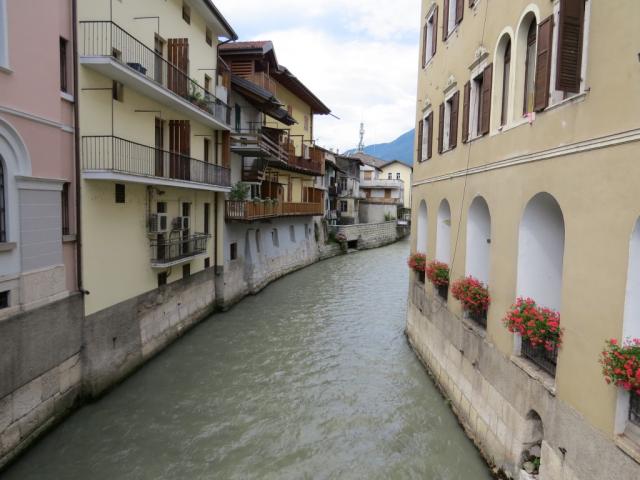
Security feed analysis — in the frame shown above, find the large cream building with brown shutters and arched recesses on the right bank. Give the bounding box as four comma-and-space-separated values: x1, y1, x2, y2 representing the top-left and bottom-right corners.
407, 0, 640, 480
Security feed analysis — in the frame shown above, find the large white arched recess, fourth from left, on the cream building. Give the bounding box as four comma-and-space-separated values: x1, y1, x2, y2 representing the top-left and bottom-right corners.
517, 192, 565, 310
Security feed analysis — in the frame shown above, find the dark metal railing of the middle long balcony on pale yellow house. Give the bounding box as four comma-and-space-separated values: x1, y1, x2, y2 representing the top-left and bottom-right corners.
82, 136, 231, 187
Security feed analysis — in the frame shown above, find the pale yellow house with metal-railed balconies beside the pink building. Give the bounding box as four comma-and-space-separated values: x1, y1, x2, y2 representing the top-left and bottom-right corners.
77, 0, 237, 391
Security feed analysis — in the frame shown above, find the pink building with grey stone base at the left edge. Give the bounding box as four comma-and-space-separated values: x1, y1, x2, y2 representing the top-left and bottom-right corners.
0, 0, 82, 467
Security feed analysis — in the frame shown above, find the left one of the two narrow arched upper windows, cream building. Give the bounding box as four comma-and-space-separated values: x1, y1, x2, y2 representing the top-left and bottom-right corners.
491, 31, 515, 131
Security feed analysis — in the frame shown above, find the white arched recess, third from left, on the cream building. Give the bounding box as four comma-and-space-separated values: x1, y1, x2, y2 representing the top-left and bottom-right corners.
466, 197, 491, 284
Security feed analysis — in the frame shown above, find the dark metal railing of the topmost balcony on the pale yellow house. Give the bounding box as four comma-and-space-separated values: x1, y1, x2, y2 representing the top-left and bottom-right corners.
79, 20, 231, 125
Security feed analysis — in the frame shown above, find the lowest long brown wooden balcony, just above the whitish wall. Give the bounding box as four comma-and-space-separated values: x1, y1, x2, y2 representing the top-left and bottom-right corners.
225, 200, 324, 222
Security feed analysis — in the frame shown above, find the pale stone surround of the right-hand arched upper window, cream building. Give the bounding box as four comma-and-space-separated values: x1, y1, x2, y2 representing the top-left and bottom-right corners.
511, 5, 540, 118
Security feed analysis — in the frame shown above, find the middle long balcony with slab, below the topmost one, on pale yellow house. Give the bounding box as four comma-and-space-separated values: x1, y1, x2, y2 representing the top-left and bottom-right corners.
82, 136, 231, 192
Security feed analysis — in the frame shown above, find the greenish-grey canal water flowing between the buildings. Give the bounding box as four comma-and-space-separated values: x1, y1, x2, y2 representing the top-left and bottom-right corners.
0, 242, 491, 480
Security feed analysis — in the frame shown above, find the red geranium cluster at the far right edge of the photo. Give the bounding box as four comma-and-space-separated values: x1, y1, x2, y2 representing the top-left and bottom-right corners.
600, 338, 640, 395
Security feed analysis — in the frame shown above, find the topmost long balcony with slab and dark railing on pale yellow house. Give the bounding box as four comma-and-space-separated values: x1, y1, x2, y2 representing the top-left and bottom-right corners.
78, 21, 231, 130
